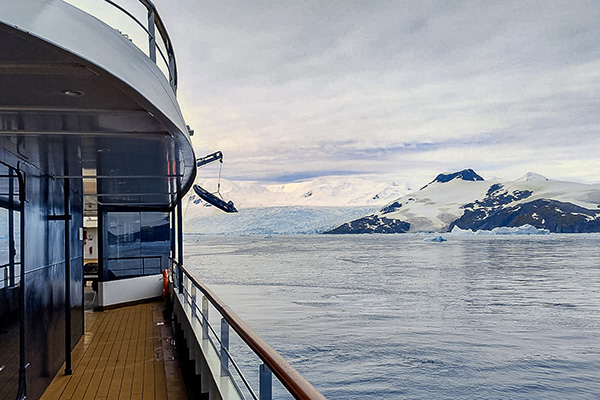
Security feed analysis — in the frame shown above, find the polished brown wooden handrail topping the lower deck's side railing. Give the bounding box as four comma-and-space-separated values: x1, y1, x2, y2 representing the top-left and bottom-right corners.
176, 264, 325, 400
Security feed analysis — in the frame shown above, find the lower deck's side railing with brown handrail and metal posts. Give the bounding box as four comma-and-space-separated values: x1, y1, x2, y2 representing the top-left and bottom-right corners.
171, 260, 325, 400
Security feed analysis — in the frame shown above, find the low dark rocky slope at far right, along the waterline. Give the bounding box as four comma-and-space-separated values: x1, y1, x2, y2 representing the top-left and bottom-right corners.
450, 199, 600, 233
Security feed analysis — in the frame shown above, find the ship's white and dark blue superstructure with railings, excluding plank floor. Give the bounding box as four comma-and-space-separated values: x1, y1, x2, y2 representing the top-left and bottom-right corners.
0, 0, 321, 400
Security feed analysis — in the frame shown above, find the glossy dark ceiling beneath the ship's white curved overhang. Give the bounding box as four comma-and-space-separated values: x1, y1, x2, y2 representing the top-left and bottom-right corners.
0, 23, 193, 211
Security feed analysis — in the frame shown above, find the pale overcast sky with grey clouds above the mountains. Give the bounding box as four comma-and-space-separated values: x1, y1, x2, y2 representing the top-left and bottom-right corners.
77, 0, 600, 185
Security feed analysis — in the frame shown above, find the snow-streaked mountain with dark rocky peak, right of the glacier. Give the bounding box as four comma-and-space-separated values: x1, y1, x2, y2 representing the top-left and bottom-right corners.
327, 170, 600, 233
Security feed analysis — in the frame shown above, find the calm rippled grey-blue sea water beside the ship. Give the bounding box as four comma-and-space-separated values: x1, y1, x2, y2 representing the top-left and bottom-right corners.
186, 235, 600, 399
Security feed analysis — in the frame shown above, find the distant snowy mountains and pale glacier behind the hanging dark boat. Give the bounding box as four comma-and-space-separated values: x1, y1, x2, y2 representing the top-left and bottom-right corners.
184, 176, 409, 235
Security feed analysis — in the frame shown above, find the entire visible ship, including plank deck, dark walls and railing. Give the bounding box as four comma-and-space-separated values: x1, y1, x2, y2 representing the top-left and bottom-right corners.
0, 0, 324, 400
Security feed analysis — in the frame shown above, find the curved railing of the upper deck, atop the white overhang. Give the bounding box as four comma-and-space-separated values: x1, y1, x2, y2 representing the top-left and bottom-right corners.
66, 0, 177, 93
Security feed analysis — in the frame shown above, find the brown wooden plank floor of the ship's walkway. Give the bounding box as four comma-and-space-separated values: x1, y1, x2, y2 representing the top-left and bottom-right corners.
41, 302, 187, 400
